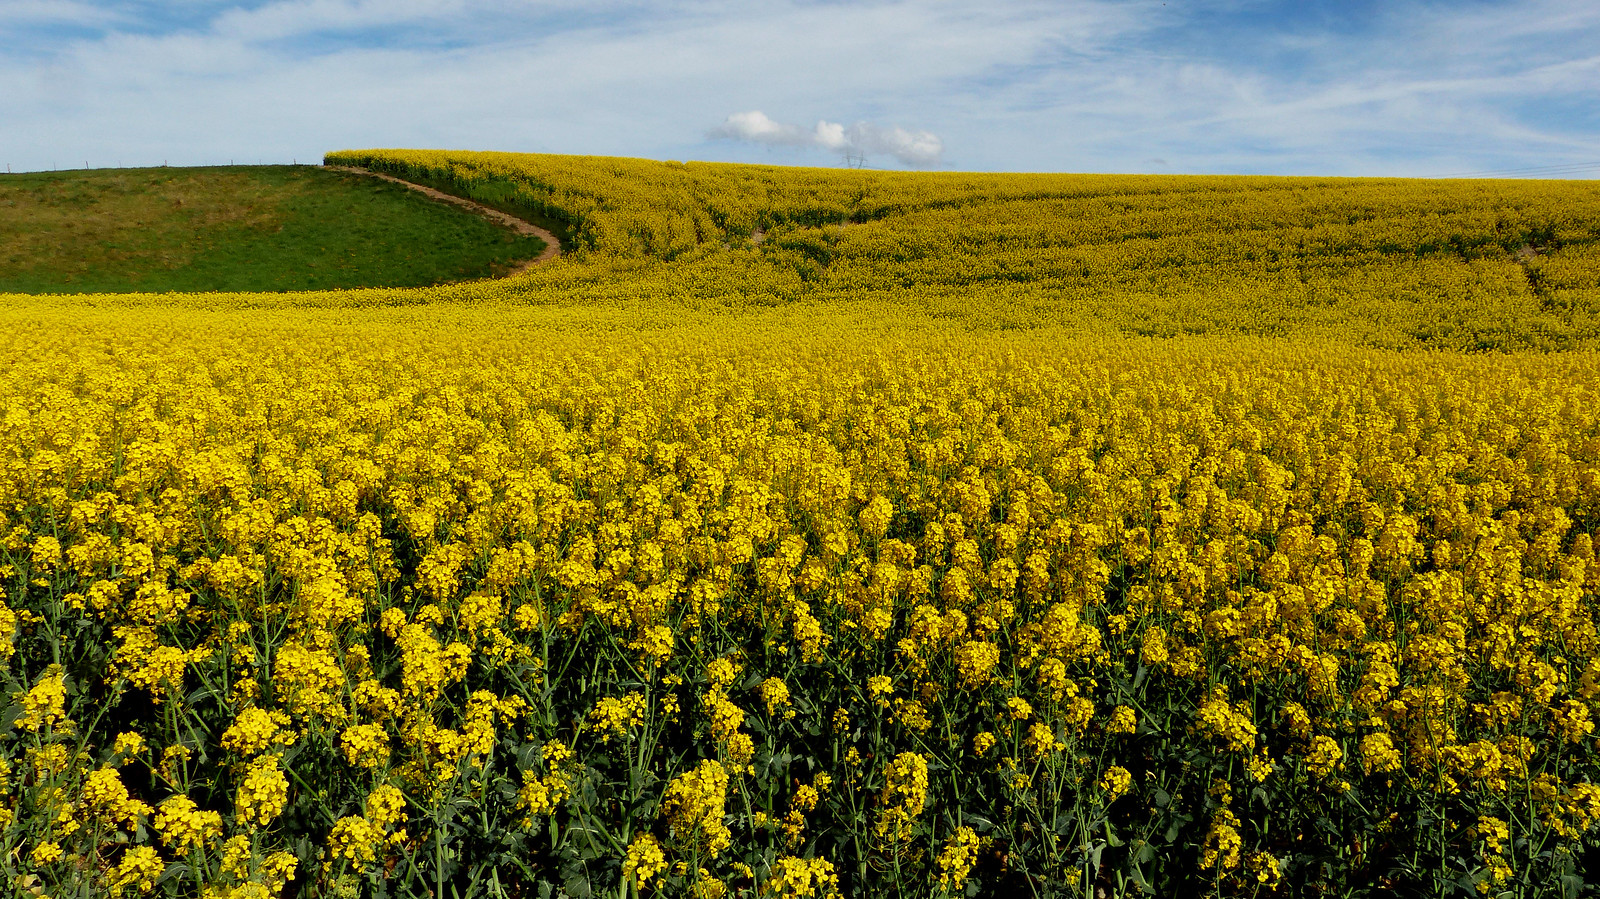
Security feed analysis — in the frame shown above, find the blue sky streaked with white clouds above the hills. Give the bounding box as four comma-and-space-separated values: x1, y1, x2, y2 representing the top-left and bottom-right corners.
0, 0, 1600, 178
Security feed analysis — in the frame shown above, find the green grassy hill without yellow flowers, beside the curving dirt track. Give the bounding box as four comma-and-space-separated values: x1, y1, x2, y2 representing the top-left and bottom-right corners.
0, 166, 544, 293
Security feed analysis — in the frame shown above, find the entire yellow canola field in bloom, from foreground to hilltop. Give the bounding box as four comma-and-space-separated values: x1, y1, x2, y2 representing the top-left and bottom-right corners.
0, 150, 1600, 899
